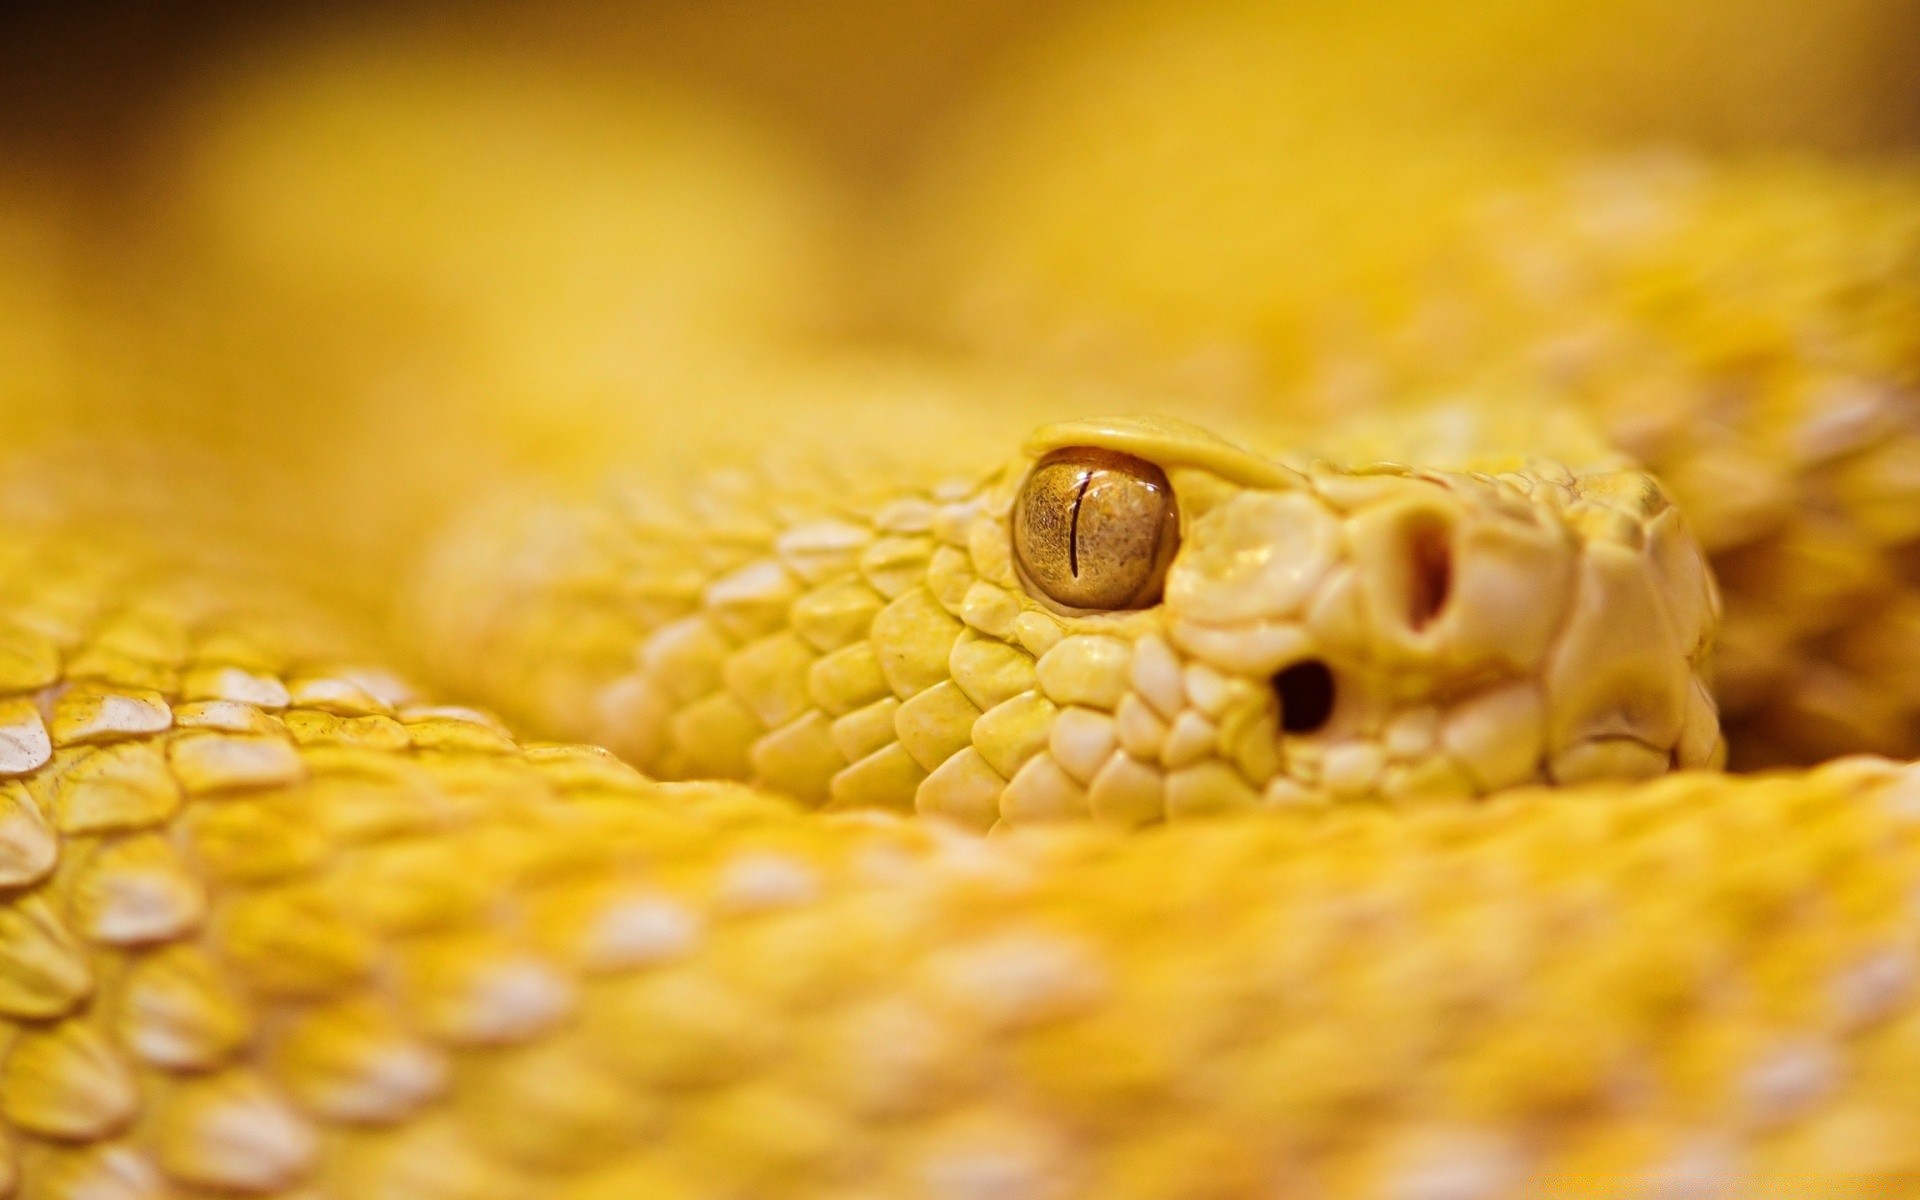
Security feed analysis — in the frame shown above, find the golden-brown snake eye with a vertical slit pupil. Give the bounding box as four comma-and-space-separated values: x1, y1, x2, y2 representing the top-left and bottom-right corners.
1014, 445, 1181, 611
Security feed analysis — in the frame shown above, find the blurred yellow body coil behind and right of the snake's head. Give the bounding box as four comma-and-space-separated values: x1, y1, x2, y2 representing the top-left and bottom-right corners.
908, 65, 1920, 766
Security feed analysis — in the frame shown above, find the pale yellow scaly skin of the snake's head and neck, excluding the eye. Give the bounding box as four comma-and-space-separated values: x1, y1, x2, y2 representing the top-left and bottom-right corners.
413, 410, 1722, 828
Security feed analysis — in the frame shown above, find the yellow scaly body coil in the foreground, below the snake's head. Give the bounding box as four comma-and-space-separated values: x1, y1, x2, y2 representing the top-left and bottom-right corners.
0, 483, 1920, 1200
